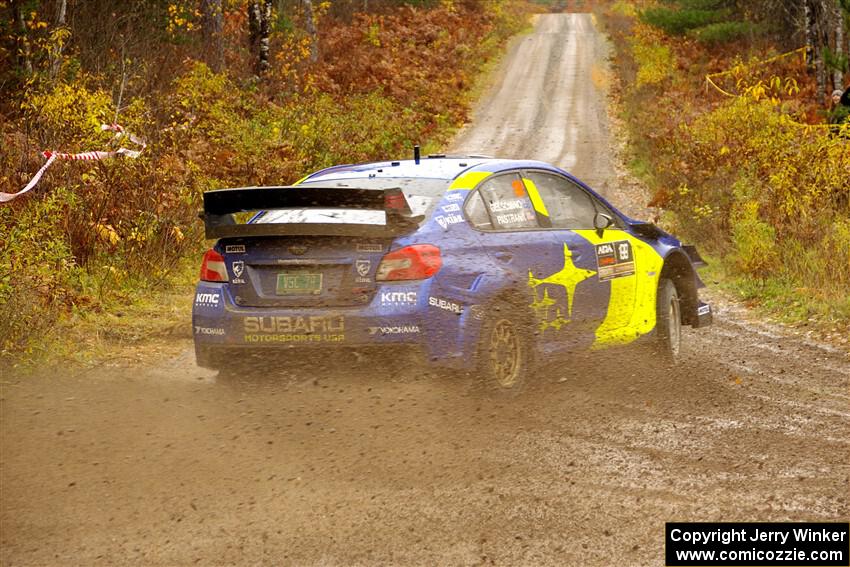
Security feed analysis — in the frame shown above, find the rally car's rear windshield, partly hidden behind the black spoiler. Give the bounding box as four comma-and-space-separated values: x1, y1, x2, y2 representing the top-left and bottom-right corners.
252, 177, 451, 225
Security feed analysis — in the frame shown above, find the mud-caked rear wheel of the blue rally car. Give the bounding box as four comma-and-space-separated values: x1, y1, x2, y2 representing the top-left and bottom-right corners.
477, 305, 532, 395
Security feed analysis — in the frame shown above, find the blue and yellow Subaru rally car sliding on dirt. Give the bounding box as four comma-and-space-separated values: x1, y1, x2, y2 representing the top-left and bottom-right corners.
192, 156, 712, 389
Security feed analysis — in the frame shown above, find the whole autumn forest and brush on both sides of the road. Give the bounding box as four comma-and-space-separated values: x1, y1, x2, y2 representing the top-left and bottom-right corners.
0, 0, 850, 364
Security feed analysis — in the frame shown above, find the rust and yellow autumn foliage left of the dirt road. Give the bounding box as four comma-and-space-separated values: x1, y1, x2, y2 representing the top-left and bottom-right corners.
0, 0, 524, 354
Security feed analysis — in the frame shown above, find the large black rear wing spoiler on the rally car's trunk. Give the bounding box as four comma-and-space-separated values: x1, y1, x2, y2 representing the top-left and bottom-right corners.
201, 185, 423, 239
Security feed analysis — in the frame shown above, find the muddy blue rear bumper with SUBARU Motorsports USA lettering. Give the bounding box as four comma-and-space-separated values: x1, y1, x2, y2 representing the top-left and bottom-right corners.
192, 281, 480, 367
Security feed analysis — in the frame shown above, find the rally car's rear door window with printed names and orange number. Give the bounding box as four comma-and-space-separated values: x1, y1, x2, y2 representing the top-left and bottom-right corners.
466, 174, 538, 230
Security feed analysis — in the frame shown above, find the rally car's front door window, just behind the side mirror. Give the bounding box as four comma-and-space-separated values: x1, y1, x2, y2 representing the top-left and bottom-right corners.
525, 171, 596, 229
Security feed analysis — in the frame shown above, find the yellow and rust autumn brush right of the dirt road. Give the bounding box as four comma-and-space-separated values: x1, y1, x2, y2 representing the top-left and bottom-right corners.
607, 3, 850, 320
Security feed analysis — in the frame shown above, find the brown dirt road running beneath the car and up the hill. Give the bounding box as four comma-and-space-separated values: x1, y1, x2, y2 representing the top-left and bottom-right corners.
0, 15, 850, 566
